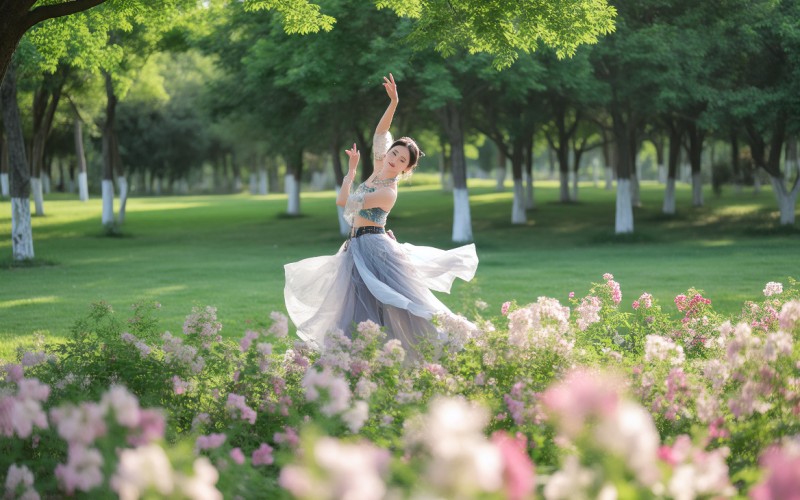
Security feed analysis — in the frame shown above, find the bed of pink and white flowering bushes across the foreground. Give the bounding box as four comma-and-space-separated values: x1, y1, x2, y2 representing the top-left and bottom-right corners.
0, 274, 800, 499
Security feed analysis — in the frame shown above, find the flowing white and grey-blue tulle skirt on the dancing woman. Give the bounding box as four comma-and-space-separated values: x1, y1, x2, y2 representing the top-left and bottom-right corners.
284, 234, 478, 358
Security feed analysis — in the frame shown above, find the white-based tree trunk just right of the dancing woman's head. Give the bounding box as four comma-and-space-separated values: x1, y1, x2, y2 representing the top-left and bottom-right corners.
440, 102, 472, 243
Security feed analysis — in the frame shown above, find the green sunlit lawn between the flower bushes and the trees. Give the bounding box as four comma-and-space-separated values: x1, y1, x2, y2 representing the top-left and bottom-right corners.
0, 180, 800, 357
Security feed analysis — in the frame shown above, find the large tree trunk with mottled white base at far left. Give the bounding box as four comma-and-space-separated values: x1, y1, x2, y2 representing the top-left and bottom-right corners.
0, 65, 34, 260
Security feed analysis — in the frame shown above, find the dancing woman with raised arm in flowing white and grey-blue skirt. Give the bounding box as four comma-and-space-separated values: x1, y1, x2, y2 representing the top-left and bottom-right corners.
284, 74, 478, 361
